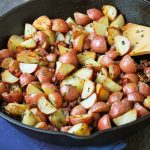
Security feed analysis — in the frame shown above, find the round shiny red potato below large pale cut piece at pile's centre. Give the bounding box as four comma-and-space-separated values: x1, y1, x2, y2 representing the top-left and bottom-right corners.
60, 85, 79, 101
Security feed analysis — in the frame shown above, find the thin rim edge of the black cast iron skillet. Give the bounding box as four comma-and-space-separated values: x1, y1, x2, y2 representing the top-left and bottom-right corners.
0, 0, 150, 140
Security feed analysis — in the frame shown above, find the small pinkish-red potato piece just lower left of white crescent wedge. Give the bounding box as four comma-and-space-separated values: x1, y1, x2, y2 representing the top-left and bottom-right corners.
70, 105, 87, 116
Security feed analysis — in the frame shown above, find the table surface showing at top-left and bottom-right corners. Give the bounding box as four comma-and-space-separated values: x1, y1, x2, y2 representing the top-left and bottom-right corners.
0, 0, 150, 150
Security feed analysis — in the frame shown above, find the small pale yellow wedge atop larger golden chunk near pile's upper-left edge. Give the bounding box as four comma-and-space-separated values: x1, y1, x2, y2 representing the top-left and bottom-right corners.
18, 38, 36, 49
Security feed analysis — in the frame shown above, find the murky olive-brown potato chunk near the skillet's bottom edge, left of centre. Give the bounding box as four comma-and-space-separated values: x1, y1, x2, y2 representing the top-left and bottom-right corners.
49, 109, 67, 128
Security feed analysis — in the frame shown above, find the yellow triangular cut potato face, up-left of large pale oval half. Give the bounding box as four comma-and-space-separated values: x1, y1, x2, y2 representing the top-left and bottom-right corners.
26, 83, 43, 95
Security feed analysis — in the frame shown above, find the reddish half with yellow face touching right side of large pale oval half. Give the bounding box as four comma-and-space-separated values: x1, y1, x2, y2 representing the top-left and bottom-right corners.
48, 92, 62, 108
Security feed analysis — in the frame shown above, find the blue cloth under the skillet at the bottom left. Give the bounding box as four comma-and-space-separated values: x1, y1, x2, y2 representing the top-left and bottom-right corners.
0, 117, 126, 150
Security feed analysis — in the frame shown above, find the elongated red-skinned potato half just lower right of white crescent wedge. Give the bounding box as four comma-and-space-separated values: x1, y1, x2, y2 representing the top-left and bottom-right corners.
89, 102, 110, 113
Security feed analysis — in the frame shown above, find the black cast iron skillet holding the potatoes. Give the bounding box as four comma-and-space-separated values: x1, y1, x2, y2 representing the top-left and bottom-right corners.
0, 0, 150, 146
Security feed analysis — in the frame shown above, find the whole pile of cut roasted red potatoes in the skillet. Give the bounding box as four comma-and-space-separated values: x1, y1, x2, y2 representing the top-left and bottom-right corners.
0, 5, 150, 136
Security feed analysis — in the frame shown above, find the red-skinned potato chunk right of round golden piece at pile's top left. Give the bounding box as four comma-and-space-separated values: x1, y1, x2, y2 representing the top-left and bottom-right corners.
52, 19, 69, 33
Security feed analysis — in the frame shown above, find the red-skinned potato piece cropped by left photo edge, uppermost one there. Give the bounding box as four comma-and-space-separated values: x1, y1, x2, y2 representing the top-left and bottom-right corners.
0, 49, 13, 63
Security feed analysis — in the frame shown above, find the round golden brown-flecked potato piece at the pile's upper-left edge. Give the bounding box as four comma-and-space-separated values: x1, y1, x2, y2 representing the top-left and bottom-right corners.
33, 16, 51, 30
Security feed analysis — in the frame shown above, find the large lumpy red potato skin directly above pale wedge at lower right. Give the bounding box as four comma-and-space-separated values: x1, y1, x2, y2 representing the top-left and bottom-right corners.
109, 99, 132, 119
